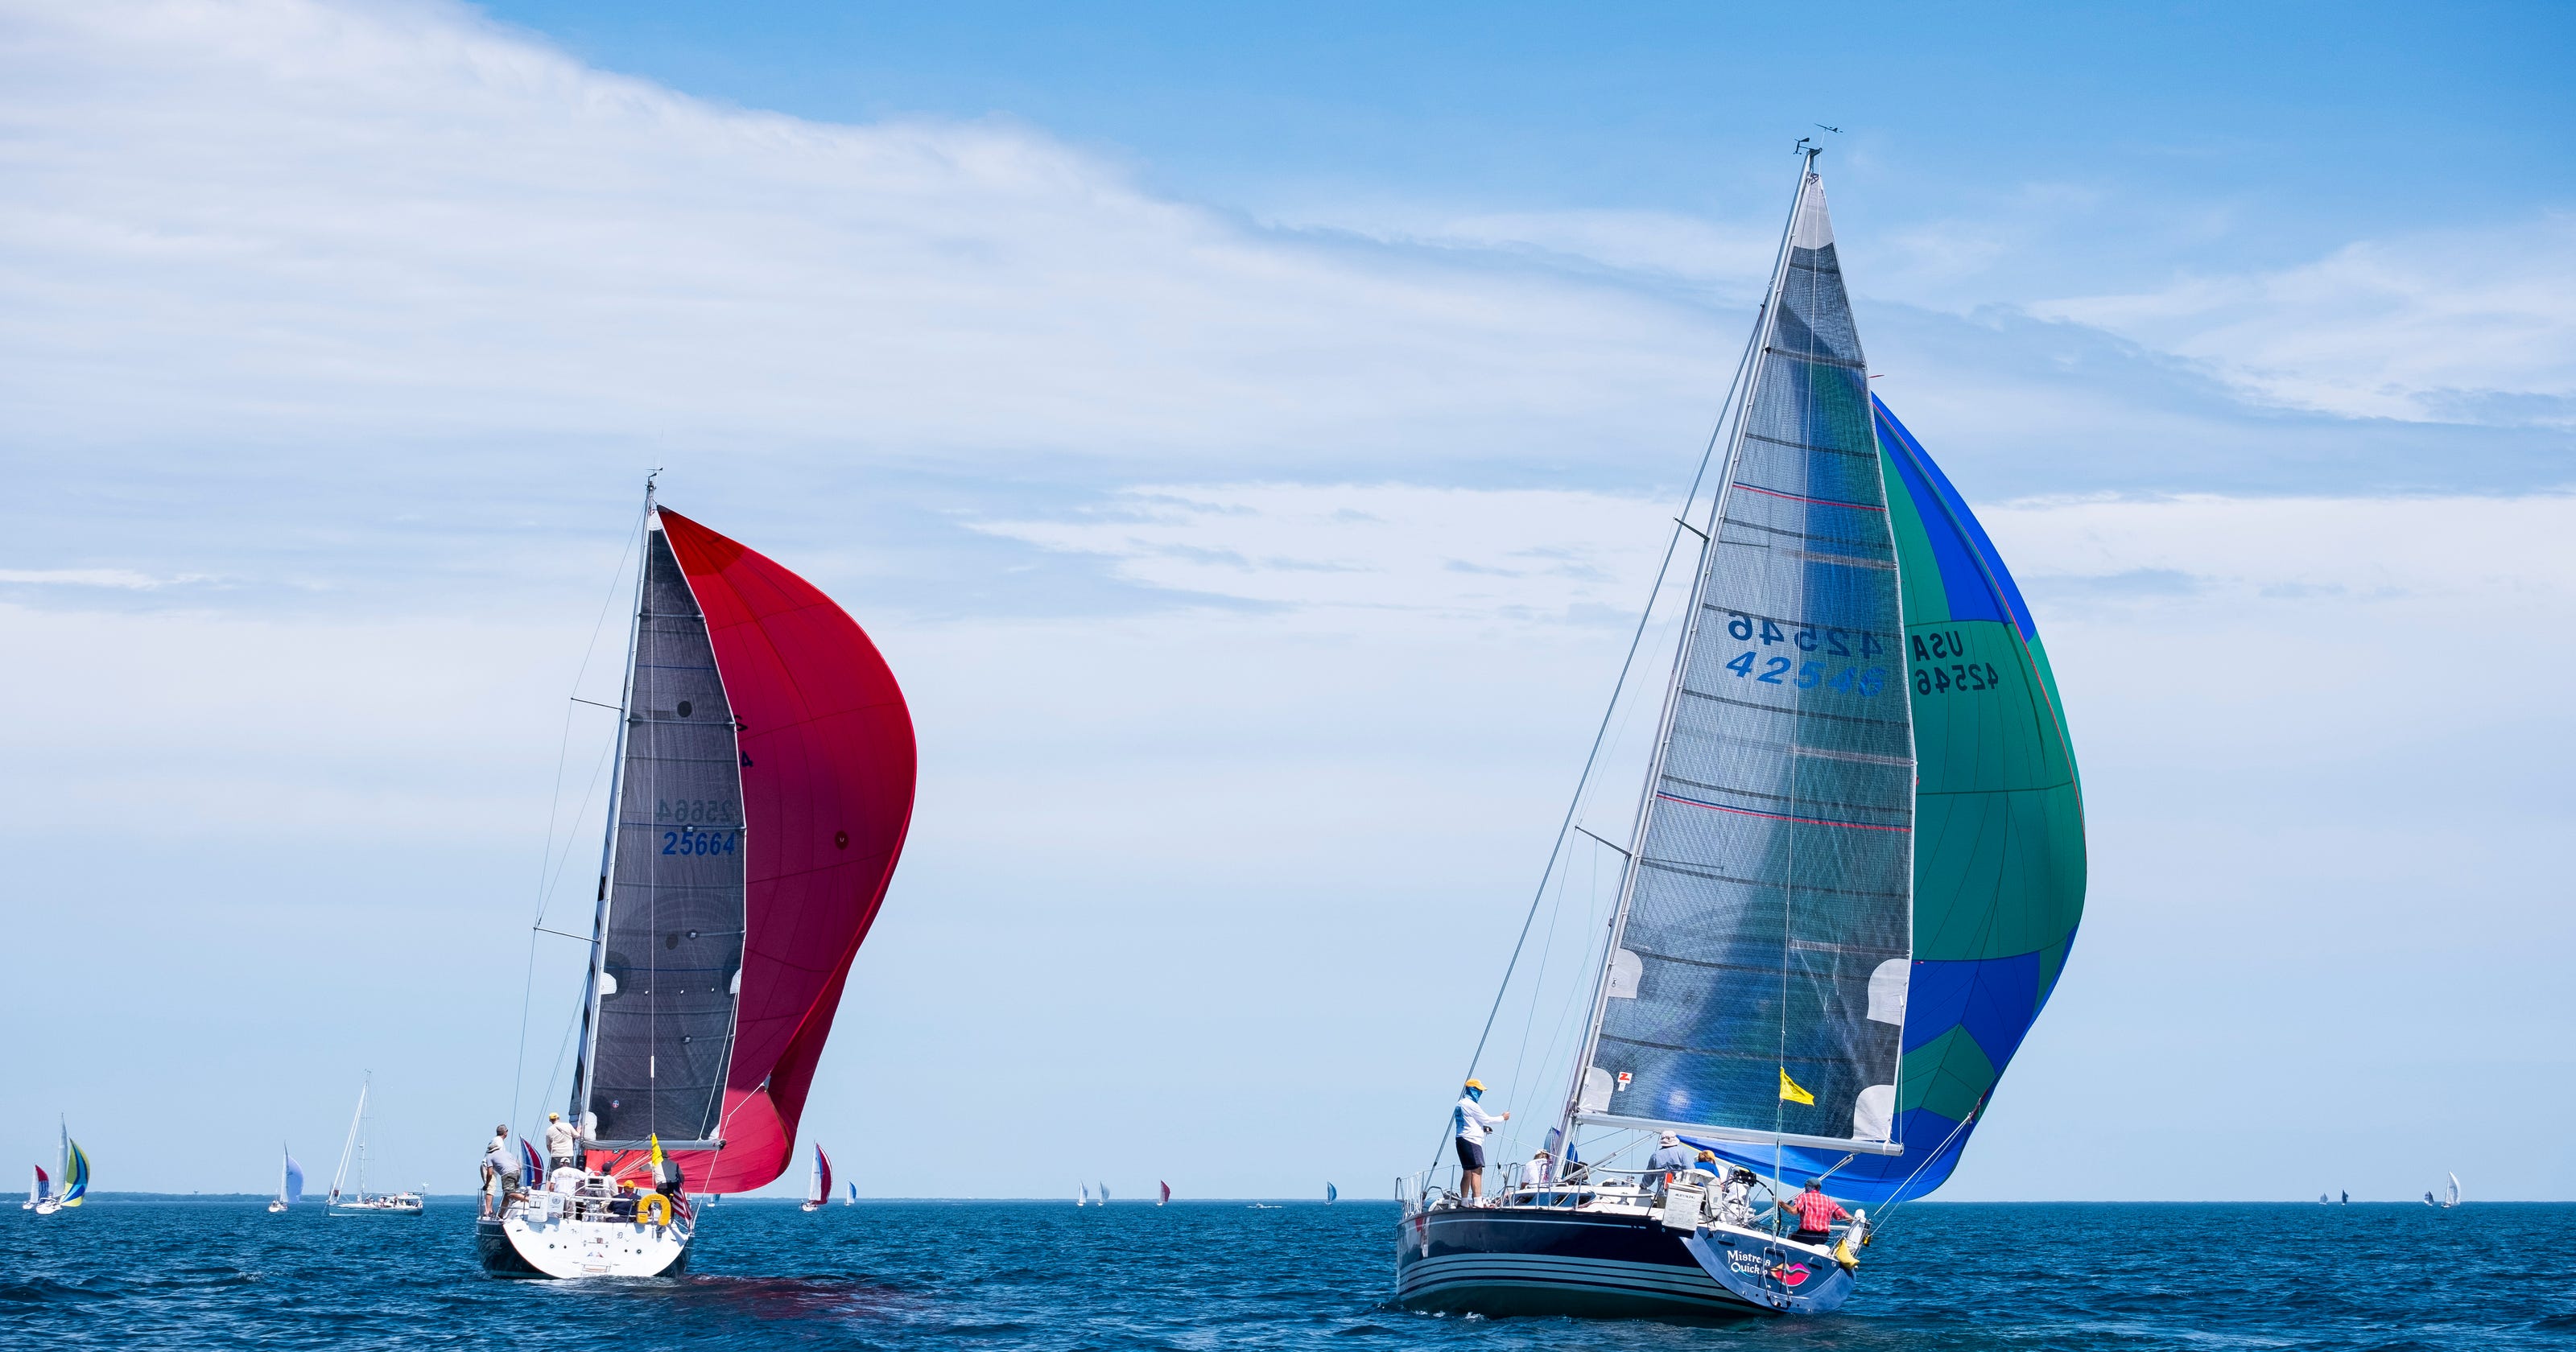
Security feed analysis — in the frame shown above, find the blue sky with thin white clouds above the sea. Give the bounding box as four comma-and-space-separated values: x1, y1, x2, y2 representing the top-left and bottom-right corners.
0, 0, 2576, 1197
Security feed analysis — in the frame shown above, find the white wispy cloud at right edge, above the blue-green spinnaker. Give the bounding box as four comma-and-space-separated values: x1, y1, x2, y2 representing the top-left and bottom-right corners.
2033, 214, 2576, 427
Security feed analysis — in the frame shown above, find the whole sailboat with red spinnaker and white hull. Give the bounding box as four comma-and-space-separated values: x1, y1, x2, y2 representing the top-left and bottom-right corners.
474, 479, 914, 1277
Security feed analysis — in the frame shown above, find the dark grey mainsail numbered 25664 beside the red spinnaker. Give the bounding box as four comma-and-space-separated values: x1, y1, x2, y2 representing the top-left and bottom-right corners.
575, 513, 745, 1148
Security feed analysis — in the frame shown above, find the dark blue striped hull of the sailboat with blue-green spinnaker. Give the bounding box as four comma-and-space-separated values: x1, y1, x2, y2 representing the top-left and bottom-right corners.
1396, 1206, 1852, 1318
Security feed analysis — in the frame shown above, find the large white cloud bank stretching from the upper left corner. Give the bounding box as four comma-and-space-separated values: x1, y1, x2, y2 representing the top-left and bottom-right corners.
0, 0, 1731, 459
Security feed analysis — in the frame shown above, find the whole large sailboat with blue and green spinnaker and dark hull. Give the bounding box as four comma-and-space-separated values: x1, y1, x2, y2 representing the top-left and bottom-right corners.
1396, 144, 2084, 1316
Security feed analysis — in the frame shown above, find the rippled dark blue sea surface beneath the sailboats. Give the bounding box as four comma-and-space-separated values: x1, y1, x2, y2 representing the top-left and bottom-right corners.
0, 1197, 2576, 1352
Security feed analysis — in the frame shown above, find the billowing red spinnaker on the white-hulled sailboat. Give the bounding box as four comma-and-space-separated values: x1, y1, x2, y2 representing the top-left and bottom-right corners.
641, 507, 914, 1193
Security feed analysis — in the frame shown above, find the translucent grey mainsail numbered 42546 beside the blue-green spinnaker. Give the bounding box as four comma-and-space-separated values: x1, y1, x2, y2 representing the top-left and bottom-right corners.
1574, 163, 1914, 1154
